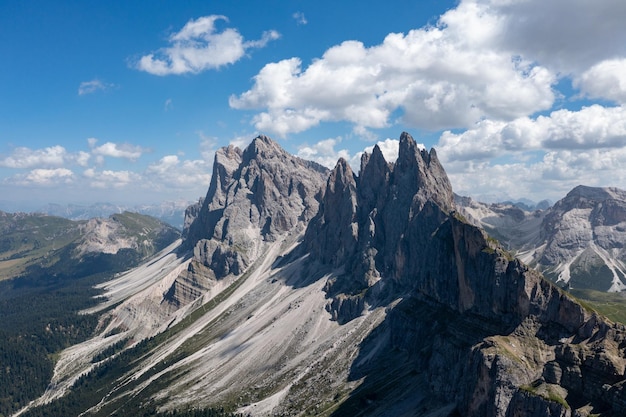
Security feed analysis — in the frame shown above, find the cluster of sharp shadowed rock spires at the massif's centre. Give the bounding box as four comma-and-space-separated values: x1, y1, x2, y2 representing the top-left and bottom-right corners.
305, 133, 453, 322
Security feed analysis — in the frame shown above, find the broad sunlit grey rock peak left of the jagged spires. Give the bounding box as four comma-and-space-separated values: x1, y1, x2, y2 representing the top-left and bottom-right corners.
167, 136, 328, 305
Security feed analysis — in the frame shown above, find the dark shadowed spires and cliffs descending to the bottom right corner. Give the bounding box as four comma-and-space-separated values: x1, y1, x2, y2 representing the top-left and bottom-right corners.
304, 134, 626, 417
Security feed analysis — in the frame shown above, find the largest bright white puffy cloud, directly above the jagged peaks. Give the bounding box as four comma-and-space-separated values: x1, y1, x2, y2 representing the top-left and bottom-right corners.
230, 2, 557, 136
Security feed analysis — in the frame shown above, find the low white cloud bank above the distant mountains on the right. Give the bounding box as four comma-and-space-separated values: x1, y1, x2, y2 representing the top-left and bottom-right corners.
436, 105, 626, 201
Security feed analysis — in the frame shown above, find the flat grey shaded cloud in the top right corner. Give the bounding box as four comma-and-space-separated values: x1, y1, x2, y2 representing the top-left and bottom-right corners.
486, 0, 626, 74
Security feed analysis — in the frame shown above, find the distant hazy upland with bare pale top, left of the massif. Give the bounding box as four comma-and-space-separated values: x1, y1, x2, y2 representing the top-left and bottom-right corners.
0, 211, 180, 279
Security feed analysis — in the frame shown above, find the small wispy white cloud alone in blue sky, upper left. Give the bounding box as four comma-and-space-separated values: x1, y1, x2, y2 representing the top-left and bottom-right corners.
135, 15, 280, 75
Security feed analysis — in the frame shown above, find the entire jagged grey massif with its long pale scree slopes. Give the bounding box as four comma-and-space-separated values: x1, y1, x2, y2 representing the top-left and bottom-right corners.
18, 133, 626, 417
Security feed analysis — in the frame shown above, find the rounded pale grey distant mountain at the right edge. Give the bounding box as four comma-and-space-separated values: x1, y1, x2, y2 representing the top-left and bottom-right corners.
534, 185, 626, 291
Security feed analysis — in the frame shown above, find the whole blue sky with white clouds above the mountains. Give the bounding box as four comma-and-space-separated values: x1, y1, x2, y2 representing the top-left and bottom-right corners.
0, 0, 626, 208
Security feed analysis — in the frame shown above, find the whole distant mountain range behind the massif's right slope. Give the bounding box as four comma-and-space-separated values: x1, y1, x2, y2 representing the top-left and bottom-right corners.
457, 185, 626, 292
